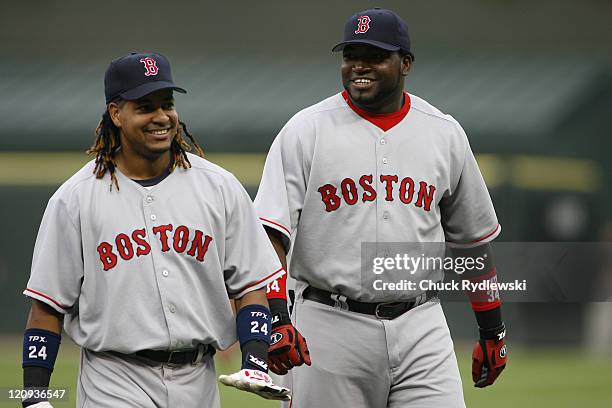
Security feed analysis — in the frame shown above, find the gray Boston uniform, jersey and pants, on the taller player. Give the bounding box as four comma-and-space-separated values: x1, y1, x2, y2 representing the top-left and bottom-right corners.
255, 94, 500, 408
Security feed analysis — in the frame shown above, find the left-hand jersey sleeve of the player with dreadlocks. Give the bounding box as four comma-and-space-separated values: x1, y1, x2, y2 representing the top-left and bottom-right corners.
23, 193, 83, 314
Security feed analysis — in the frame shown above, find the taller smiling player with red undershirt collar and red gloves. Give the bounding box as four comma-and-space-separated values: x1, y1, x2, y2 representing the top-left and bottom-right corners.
255, 9, 507, 408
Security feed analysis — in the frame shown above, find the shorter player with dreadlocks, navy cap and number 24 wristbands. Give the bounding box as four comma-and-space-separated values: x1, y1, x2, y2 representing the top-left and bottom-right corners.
23, 53, 289, 408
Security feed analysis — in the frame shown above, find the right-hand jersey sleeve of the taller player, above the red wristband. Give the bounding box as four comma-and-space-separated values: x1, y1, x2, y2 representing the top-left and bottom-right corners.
440, 124, 501, 245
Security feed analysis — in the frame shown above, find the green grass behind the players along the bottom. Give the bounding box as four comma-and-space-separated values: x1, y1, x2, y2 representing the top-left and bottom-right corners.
0, 336, 612, 408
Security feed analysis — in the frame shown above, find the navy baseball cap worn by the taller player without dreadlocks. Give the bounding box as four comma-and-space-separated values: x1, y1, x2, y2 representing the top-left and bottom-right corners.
332, 7, 414, 59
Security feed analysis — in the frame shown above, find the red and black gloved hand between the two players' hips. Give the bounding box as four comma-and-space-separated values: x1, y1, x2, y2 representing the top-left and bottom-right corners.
268, 323, 311, 375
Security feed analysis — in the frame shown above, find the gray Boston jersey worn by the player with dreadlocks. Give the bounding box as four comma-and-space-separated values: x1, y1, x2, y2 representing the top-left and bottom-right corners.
24, 154, 282, 353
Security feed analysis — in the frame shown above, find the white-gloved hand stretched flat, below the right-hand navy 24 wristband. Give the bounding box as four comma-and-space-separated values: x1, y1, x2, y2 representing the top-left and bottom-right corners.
219, 369, 291, 401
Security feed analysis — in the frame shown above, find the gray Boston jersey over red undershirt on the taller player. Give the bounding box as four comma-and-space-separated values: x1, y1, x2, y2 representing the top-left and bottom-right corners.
255, 94, 501, 302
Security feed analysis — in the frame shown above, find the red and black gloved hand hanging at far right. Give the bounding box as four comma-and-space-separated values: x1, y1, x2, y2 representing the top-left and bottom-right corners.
472, 324, 508, 388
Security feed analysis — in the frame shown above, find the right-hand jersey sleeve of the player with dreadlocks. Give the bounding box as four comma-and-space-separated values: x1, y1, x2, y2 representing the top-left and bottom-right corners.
223, 180, 284, 298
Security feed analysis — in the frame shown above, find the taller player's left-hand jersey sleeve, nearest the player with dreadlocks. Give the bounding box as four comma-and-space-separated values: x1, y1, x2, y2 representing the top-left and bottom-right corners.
255, 117, 308, 251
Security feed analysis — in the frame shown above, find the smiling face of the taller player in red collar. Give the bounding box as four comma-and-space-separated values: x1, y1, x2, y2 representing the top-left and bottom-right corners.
341, 44, 410, 113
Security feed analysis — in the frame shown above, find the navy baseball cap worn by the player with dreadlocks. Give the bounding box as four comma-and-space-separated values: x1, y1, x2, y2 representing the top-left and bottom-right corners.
104, 52, 187, 104
